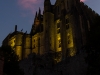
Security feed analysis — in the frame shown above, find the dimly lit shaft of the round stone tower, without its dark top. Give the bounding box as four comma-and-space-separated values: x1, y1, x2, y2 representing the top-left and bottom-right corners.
43, 12, 55, 52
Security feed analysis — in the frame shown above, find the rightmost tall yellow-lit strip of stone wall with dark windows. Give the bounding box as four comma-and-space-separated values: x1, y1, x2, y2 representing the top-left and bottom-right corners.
65, 15, 76, 56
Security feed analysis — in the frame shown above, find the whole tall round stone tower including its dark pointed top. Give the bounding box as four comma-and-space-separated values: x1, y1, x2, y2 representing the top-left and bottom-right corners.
43, 0, 55, 52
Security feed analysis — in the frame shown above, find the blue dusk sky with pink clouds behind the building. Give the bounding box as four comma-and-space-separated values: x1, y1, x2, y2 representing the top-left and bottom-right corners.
0, 0, 100, 46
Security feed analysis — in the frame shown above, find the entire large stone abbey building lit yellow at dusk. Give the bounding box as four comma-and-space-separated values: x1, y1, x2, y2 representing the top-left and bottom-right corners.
3, 0, 98, 62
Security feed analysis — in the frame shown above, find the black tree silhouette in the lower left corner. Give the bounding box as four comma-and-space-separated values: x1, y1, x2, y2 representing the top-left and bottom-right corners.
0, 46, 23, 75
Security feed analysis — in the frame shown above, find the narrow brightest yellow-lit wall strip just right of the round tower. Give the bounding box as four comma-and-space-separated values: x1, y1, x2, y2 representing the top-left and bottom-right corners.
54, 19, 62, 63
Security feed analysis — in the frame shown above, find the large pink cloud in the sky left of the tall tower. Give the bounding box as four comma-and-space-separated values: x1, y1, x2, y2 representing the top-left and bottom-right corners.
18, 0, 43, 14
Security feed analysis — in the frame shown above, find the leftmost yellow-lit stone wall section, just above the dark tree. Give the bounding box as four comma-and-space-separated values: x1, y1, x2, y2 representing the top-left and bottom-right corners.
5, 33, 23, 60
